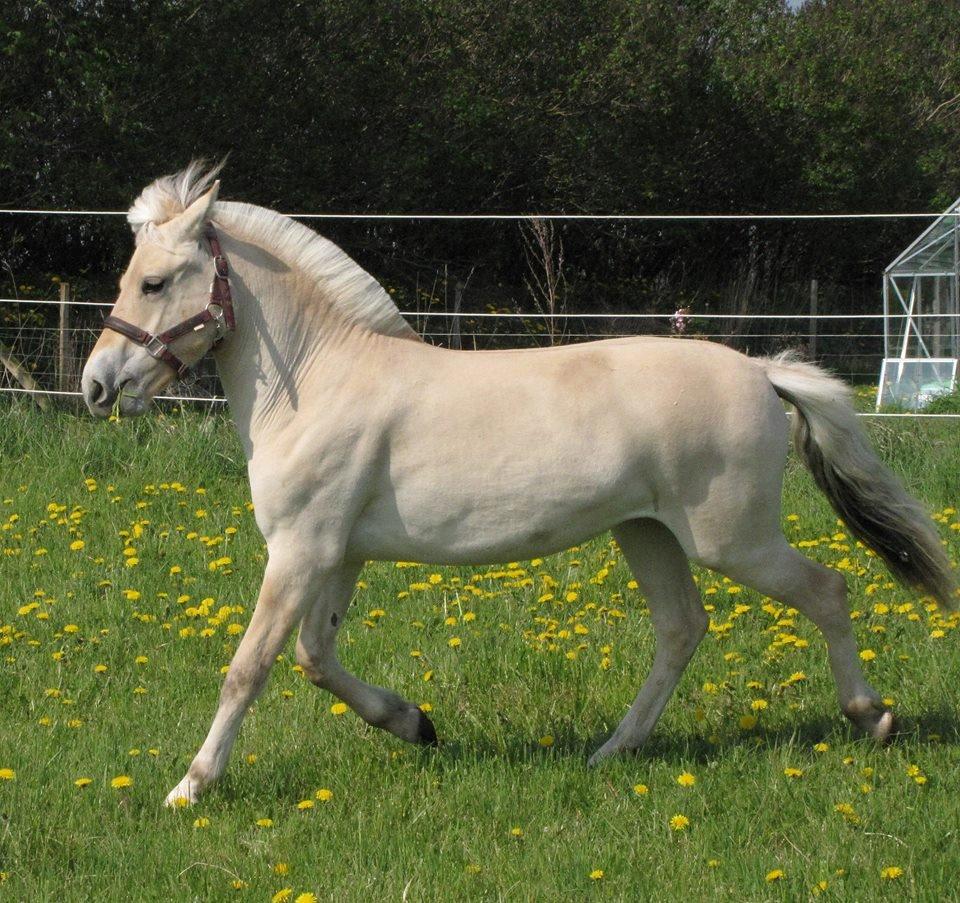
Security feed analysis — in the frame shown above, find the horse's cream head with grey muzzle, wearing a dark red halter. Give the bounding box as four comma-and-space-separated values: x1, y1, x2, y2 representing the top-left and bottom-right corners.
81, 182, 222, 417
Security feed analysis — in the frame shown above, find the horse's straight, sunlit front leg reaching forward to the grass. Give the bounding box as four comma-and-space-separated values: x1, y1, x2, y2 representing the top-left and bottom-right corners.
166, 550, 326, 806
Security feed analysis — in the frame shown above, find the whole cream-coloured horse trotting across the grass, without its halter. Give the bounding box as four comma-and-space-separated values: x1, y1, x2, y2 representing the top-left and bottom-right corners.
83, 166, 954, 803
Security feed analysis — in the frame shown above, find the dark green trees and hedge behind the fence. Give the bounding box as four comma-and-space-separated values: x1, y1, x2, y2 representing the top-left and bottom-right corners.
0, 0, 960, 330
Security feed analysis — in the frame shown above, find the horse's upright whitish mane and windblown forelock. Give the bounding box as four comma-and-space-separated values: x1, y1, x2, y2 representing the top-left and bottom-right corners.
127, 161, 417, 338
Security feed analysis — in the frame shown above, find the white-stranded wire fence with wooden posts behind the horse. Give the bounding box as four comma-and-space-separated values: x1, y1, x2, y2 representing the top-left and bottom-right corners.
0, 209, 958, 417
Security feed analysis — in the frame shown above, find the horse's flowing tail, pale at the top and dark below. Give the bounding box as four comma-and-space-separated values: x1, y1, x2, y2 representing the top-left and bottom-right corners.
758, 354, 957, 609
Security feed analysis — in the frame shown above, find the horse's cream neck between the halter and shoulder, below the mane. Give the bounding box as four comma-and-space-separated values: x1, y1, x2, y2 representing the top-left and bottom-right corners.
216, 246, 364, 459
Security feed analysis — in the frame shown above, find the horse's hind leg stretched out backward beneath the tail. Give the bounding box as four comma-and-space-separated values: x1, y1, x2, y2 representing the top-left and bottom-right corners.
705, 531, 893, 740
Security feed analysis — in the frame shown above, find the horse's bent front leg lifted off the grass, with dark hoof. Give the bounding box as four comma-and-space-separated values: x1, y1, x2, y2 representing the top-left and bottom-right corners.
297, 564, 437, 744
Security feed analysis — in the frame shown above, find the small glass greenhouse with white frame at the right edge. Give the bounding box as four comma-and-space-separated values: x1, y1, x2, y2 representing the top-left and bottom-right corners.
877, 198, 960, 410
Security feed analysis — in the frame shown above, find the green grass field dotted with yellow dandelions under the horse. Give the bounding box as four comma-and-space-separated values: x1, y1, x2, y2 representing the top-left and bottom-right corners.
0, 403, 960, 903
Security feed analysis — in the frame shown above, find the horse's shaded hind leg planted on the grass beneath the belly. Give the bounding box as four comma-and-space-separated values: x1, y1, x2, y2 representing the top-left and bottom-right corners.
590, 520, 708, 765
